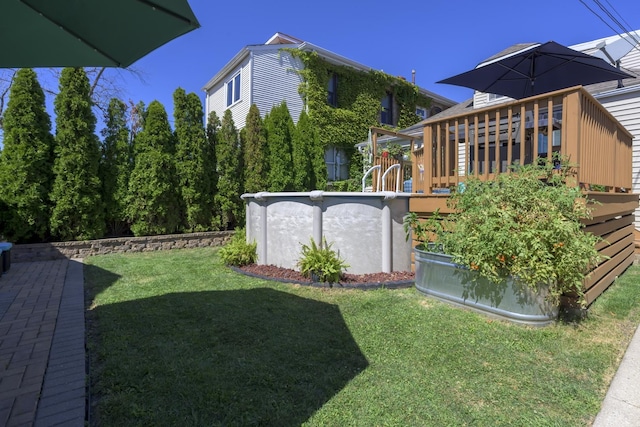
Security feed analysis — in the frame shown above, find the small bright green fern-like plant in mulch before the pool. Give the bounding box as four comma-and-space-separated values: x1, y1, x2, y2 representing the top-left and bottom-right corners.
298, 237, 349, 283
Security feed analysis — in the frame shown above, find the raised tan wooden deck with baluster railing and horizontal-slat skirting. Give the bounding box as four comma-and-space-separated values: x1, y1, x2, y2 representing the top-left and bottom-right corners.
374, 86, 640, 304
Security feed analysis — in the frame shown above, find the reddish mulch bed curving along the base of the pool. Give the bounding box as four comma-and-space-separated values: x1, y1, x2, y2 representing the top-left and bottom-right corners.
237, 264, 415, 287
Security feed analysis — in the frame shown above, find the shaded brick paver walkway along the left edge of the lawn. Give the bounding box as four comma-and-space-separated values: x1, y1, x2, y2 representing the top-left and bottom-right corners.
0, 259, 86, 426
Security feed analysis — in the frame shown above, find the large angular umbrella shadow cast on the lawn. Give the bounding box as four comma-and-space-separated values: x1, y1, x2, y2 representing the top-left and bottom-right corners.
85, 280, 368, 426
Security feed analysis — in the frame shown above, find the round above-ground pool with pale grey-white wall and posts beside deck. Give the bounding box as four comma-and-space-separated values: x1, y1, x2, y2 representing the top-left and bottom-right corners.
242, 191, 411, 274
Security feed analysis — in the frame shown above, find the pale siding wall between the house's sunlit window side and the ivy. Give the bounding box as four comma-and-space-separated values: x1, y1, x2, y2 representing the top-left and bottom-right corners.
252, 48, 304, 123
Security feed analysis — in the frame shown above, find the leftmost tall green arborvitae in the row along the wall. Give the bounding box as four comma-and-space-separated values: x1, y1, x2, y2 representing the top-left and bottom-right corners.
0, 68, 53, 243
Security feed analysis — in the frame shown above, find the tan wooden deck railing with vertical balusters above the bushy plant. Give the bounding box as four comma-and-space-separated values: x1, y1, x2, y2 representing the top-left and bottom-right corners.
412, 86, 633, 194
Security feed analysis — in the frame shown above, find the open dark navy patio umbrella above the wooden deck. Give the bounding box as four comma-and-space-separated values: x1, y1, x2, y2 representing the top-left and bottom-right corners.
438, 41, 634, 99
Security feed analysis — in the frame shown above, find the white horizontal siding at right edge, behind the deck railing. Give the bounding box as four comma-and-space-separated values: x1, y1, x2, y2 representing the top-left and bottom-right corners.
596, 88, 640, 229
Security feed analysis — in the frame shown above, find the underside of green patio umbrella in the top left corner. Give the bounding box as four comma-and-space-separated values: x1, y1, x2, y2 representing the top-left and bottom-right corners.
0, 0, 200, 68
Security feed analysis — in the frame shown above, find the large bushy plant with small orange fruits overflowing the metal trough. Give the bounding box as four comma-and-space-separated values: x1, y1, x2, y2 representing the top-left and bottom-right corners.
405, 159, 602, 308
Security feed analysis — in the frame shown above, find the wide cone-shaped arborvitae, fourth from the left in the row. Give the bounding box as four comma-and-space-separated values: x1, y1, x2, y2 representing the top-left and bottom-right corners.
127, 101, 182, 236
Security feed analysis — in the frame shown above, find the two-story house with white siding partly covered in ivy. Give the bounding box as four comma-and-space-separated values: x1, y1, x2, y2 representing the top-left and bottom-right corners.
203, 33, 456, 181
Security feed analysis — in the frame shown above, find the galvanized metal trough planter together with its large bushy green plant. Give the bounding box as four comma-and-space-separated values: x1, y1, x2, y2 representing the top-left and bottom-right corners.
405, 160, 600, 324
